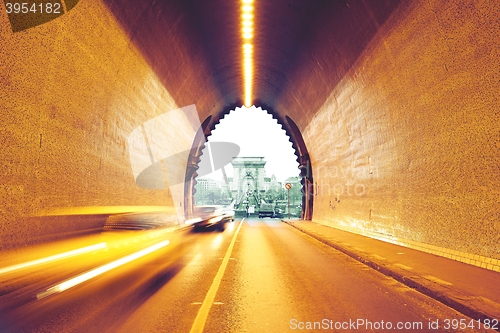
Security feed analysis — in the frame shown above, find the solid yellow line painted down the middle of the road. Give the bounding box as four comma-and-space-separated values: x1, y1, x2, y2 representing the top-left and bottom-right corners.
189, 219, 245, 333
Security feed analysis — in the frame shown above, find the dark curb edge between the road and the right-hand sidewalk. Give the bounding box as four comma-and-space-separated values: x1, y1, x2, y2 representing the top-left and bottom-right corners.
281, 220, 500, 332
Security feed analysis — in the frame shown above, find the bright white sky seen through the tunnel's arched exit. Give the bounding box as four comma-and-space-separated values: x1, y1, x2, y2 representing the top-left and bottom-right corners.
201, 106, 299, 181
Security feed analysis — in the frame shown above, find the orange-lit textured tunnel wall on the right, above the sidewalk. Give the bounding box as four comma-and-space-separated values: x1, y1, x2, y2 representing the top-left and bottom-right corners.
302, 1, 500, 271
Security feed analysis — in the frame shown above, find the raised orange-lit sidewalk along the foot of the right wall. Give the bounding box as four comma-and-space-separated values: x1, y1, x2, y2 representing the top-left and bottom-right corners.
283, 220, 500, 331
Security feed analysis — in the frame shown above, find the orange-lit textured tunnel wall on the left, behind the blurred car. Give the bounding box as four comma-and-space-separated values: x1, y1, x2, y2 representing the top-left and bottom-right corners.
0, 1, 193, 250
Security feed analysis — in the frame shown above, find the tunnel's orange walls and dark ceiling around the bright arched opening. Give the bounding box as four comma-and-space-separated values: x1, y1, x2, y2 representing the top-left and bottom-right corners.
0, 0, 500, 271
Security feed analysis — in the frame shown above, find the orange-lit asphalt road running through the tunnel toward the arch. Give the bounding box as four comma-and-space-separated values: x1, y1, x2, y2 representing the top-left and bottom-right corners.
0, 219, 492, 333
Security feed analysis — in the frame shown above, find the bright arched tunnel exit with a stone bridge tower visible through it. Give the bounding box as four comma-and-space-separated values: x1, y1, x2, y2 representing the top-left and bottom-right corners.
186, 107, 313, 219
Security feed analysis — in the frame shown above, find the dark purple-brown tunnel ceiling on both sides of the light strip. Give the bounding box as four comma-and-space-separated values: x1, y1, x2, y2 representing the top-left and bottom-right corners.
106, 0, 400, 126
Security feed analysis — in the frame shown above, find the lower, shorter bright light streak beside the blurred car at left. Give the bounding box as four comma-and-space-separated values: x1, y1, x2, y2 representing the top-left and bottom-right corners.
36, 240, 170, 299
